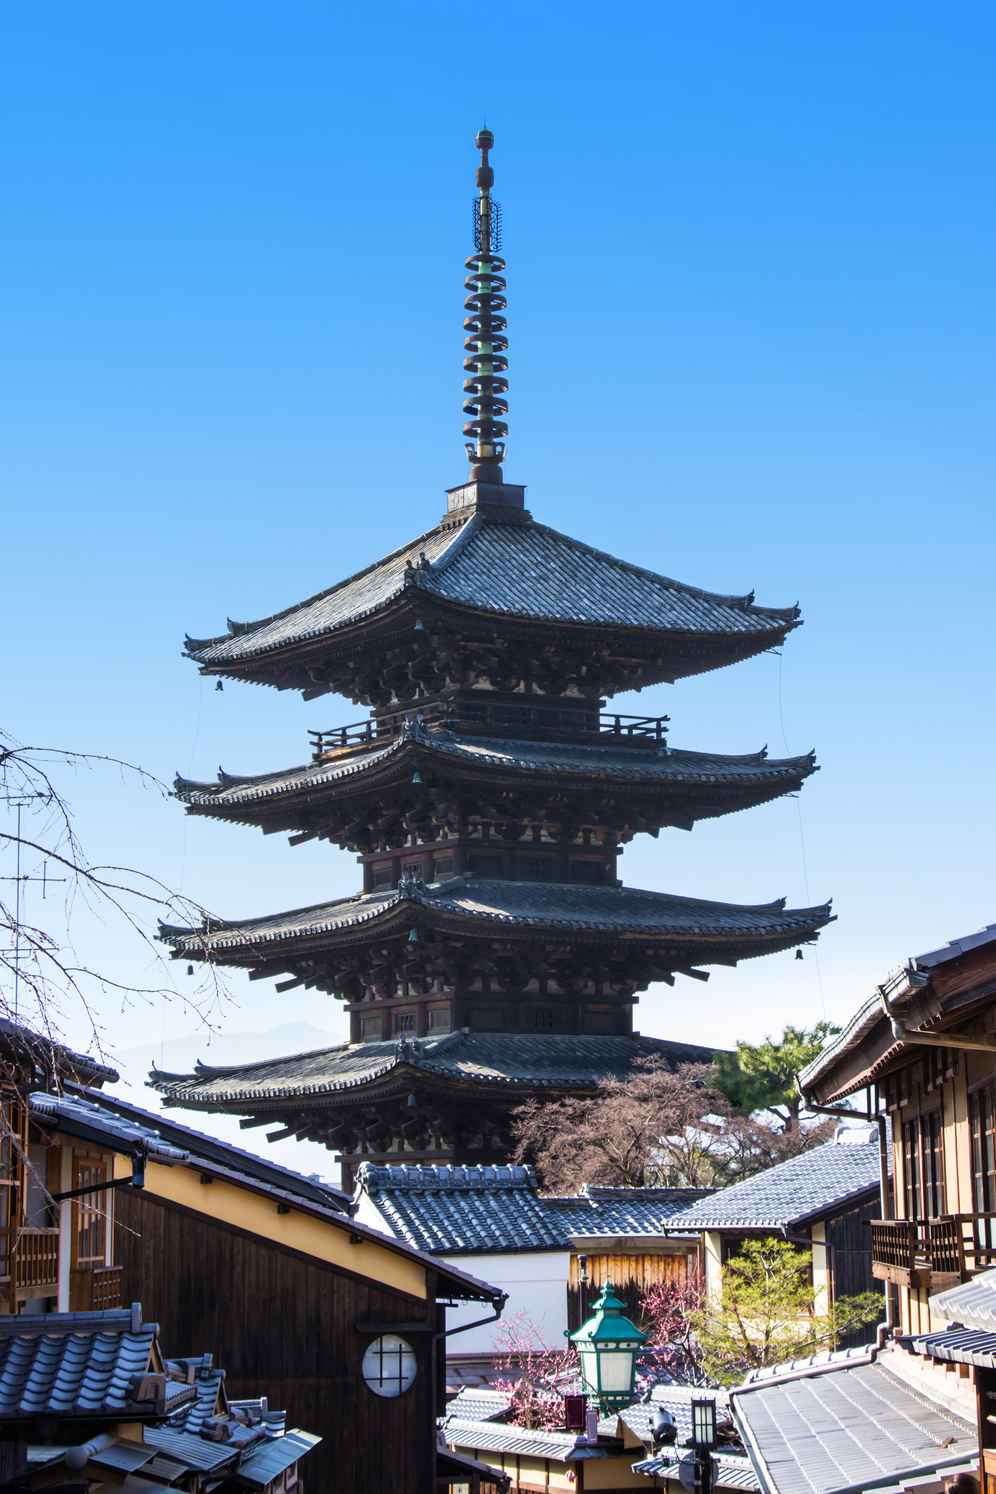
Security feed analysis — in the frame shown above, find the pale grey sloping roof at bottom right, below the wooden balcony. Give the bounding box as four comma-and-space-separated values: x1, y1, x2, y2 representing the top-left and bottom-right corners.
732, 1364, 978, 1494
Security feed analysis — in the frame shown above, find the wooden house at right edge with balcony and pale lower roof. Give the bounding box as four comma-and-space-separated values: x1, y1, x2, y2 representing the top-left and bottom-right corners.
770, 925, 996, 1494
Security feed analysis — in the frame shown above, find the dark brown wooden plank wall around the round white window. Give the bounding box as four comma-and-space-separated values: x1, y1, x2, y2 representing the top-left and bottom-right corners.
115, 1189, 442, 1494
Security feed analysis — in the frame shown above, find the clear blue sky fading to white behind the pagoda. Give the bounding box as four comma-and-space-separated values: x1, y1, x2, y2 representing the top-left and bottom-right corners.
0, 0, 996, 1159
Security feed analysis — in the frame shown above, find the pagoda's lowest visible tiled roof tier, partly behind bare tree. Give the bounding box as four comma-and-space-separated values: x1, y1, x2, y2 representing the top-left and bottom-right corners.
151, 1032, 712, 1109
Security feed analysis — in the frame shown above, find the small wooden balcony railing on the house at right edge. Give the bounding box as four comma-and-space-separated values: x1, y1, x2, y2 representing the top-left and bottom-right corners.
872, 1213, 996, 1292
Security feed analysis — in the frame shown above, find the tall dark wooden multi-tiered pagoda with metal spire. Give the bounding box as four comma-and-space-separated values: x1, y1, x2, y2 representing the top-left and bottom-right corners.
152, 140, 830, 1176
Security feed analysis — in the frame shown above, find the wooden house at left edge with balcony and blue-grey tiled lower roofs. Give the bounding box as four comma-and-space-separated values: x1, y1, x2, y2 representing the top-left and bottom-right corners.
0, 1020, 321, 1494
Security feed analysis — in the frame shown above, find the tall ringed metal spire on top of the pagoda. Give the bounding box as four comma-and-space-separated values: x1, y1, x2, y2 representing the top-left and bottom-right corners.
463, 128, 508, 483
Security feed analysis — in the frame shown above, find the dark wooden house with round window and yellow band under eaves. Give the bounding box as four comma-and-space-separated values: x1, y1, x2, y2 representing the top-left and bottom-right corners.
35, 1088, 505, 1494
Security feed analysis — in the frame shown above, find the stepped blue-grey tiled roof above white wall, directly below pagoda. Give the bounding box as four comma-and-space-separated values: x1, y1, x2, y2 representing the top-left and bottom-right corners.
357, 1162, 700, 1255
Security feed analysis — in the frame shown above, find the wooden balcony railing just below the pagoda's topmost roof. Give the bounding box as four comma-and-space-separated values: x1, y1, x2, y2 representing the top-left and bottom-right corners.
308, 699, 669, 760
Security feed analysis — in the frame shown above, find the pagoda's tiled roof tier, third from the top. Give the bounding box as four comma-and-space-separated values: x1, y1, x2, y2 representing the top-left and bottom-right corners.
161, 877, 832, 959
